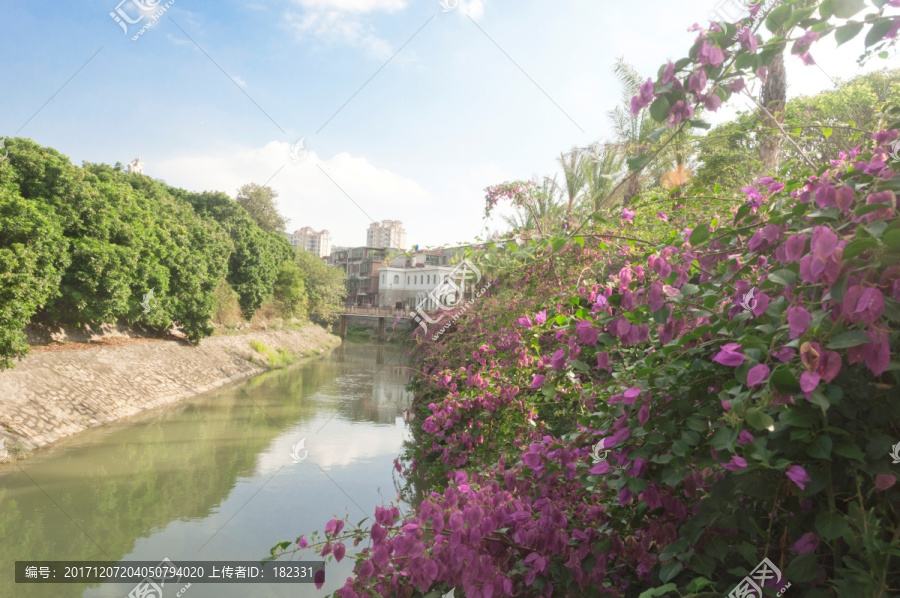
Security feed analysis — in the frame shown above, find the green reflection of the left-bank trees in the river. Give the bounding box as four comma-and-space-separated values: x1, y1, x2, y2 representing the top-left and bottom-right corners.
0, 361, 344, 598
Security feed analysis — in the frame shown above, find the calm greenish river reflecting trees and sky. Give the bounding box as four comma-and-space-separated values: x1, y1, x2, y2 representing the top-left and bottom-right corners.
0, 343, 412, 598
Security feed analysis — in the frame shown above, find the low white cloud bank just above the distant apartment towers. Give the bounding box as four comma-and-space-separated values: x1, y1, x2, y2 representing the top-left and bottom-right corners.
145, 141, 437, 246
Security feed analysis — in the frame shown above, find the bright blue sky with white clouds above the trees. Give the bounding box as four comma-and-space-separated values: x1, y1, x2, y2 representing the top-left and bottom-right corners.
0, 0, 898, 246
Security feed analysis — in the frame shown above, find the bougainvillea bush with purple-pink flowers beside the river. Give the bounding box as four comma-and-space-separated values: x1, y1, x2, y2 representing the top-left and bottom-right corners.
273, 0, 900, 598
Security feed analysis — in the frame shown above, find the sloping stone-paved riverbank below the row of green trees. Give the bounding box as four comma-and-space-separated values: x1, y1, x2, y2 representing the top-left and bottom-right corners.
0, 325, 340, 460
